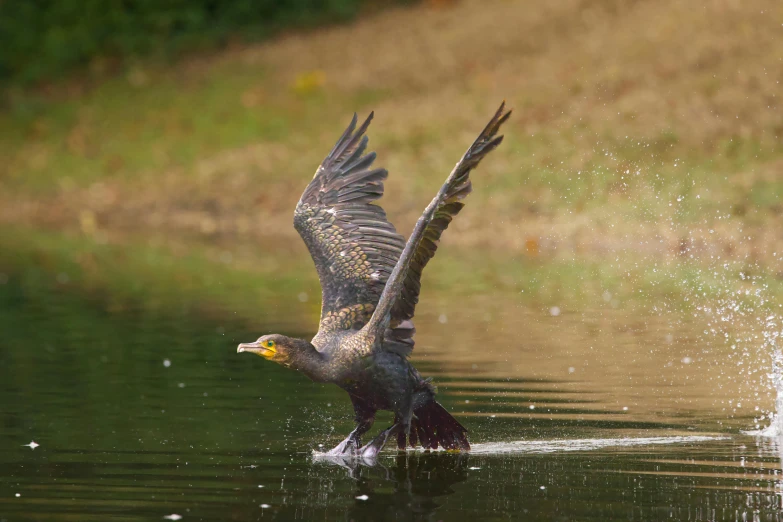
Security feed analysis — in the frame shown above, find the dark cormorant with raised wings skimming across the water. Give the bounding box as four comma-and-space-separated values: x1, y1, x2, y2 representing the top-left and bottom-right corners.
237, 102, 511, 460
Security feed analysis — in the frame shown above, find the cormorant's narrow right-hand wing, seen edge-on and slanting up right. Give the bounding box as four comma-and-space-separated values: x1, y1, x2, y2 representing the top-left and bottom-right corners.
363, 102, 511, 353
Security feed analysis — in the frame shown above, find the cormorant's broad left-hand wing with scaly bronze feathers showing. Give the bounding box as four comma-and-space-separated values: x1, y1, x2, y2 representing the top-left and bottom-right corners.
294, 113, 412, 331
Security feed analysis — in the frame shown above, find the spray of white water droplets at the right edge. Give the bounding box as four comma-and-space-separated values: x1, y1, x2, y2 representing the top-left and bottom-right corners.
620, 156, 783, 432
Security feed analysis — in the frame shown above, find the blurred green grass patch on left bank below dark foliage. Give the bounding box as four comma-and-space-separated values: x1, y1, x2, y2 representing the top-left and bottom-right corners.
0, 65, 290, 192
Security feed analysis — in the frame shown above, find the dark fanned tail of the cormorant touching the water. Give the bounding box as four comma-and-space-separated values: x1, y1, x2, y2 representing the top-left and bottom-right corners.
397, 400, 470, 451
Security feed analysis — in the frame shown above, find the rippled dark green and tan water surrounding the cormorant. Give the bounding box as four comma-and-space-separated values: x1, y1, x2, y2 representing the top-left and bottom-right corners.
0, 274, 783, 521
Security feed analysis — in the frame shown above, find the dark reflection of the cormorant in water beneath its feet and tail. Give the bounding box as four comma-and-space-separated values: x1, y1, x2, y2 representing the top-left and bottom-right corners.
313, 451, 469, 520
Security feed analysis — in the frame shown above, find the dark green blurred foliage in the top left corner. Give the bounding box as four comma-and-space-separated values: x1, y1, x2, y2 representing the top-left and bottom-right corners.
0, 0, 368, 83
